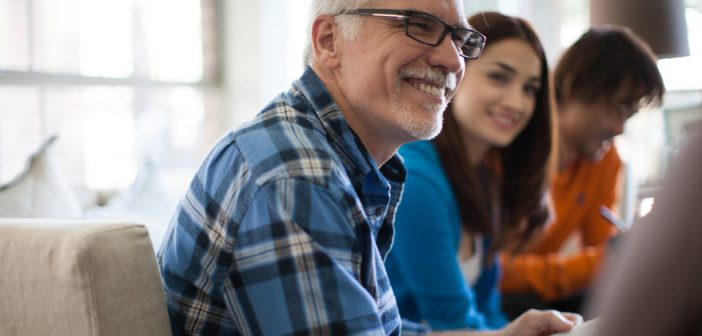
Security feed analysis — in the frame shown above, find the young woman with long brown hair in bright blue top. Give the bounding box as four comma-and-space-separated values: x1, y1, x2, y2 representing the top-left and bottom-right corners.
386, 13, 554, 330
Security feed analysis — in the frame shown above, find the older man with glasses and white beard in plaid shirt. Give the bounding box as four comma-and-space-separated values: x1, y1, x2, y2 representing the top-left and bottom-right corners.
159, 0, 578, 335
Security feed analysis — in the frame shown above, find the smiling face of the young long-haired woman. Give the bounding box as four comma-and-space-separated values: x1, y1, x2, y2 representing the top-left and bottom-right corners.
453, 38, 548, 147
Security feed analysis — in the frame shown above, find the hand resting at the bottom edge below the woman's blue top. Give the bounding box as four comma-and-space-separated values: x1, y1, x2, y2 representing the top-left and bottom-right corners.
500, 309, 583, 336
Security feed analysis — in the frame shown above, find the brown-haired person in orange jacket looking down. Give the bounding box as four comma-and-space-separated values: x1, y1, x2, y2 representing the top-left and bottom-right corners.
501, 26, 665, 317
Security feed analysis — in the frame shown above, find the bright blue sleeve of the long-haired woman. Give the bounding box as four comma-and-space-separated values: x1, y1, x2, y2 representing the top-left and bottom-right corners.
389, 174, 496, 330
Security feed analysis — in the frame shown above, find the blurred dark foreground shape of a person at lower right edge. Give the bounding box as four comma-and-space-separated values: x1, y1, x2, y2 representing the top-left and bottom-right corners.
589, 134, 702, 336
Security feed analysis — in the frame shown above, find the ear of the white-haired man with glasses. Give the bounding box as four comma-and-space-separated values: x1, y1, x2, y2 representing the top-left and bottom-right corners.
312, 15, 341, 68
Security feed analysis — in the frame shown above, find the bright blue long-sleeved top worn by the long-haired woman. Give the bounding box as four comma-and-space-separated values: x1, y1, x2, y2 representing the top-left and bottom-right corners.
385, 141, 507, 330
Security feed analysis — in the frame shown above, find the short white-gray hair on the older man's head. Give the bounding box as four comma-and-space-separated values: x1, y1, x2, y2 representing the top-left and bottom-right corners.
303, 0, 375, 65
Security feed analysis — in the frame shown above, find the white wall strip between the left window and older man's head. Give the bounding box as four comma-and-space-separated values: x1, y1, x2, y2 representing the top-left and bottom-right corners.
223, 0, 310, 127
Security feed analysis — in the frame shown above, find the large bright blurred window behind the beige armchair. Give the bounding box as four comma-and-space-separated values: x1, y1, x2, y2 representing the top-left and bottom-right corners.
0, 0, 221, 190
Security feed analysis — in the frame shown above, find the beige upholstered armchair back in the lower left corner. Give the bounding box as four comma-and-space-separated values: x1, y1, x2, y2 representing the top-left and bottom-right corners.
0, 218, 171, 336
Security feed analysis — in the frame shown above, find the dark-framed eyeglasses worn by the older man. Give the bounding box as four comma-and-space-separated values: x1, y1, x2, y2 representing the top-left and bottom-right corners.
339, 9, 486, 59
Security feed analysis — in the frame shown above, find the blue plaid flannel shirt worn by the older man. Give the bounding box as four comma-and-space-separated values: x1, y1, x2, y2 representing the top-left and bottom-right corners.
158, 68, 425, 335
